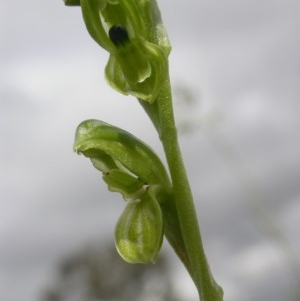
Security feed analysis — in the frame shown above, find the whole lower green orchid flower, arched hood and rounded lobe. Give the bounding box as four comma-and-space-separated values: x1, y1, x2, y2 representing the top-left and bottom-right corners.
74, 120, 166, 263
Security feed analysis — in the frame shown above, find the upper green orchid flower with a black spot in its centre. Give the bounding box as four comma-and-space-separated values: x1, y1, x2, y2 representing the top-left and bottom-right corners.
78, 0, 170, 103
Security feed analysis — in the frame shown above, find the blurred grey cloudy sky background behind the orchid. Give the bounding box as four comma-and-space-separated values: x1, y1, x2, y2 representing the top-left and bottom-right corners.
0, 0, 300, 301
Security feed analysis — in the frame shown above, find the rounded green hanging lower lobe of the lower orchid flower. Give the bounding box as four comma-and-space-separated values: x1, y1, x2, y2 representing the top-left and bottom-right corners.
115, 194, 163, 263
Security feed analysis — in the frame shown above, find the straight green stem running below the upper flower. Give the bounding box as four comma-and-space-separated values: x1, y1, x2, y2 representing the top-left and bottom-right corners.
156, 79, 223, 301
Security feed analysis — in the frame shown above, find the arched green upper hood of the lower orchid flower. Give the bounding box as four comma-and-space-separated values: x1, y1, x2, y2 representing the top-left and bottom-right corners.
74, 120, 171, 200
